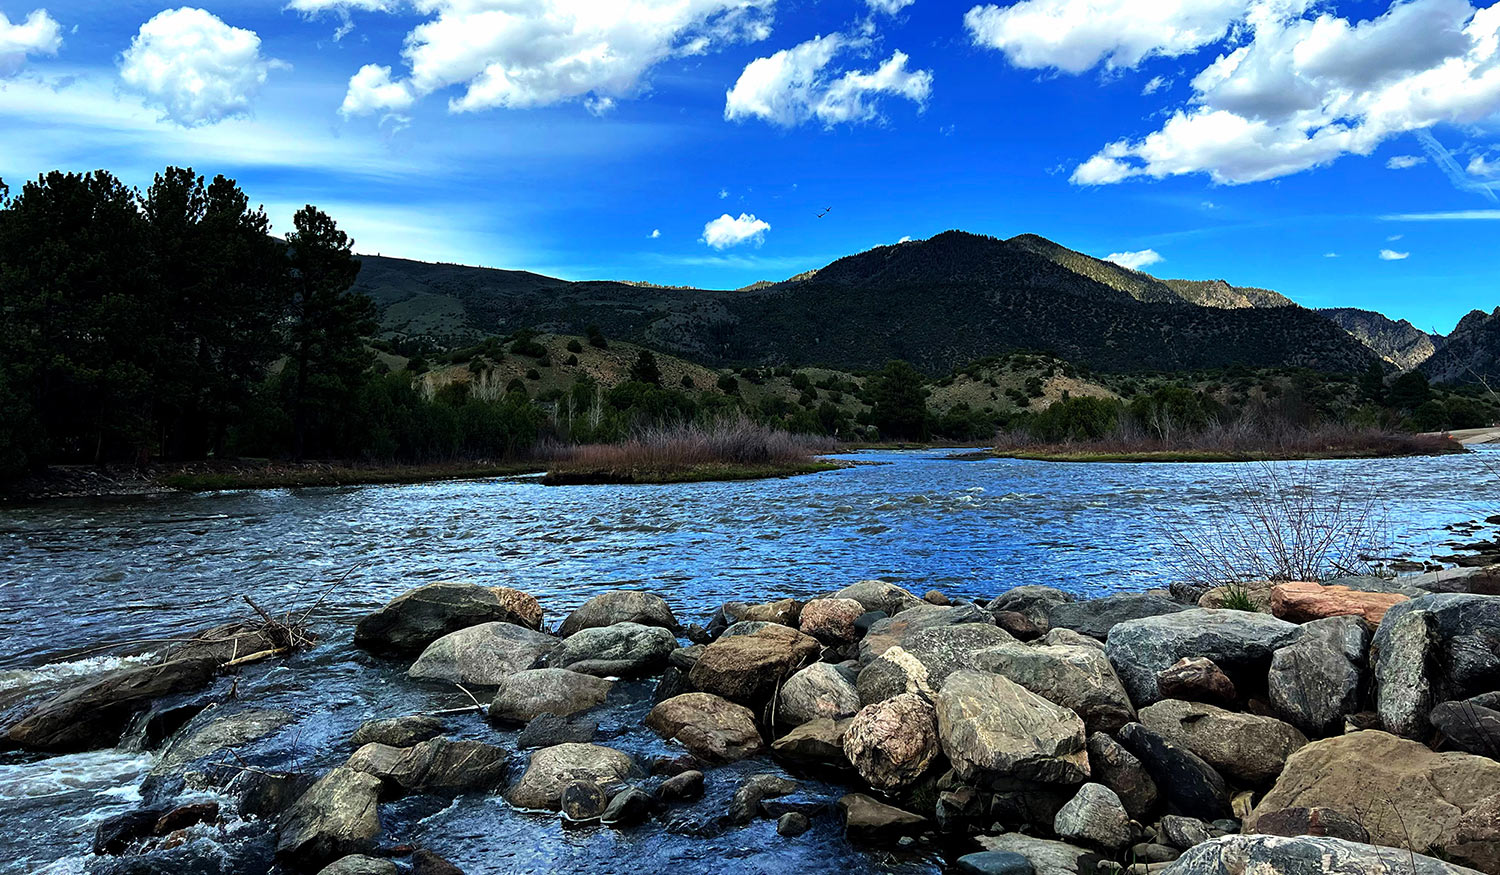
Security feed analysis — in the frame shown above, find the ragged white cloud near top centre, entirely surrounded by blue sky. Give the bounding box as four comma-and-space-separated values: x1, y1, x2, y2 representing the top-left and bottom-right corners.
725, 33, 933, 128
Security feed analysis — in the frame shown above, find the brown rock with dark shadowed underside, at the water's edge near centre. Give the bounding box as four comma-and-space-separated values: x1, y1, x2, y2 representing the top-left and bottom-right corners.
687, 626, 822, 705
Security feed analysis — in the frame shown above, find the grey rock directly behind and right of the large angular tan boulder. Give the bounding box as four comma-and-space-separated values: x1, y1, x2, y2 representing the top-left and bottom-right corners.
971, 642, 1136, 732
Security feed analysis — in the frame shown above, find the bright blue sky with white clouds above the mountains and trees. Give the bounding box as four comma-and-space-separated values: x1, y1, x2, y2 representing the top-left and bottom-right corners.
0, 0, 1500, 332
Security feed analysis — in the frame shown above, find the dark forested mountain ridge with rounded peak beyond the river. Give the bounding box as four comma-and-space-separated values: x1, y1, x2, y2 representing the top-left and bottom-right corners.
357, 231, 1374, 374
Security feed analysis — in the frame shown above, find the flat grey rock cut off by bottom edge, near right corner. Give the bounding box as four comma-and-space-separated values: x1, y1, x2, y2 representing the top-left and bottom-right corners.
1164, 836, 1473, 875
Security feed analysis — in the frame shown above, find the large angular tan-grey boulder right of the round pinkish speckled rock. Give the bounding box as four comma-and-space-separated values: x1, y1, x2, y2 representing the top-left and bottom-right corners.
930, 669, 1089, 783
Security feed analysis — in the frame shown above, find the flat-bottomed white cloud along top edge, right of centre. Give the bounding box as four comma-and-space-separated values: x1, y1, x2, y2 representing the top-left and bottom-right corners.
963, 0, 1250, 74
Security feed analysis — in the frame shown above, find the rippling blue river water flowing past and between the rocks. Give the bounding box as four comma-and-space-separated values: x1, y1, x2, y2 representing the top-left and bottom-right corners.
0, 452, 1500, 875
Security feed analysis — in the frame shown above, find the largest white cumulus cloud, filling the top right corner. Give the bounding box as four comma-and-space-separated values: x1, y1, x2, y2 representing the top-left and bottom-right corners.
1062, 0, 1500, 185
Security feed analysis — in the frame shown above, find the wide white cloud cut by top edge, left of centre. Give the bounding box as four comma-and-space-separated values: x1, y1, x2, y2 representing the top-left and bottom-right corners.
342, 0, 776, 113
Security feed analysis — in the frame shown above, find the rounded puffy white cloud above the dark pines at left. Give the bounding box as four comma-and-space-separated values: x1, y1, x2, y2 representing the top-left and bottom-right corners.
120, 6, 284, 126
